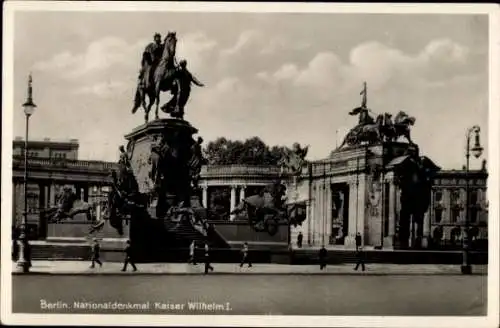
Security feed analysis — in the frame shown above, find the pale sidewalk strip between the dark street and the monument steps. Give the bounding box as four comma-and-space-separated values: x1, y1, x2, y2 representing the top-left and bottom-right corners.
12, 261, 488, 276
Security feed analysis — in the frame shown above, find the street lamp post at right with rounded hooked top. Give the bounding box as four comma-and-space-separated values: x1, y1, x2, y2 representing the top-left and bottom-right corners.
461, 125, 483, 274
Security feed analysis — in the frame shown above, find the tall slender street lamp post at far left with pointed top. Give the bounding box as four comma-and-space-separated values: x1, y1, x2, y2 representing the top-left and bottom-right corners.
17, 74, 36, 272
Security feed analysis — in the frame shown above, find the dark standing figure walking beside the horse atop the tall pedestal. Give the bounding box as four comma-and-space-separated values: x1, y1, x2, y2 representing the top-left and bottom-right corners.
162, 59, 205, 119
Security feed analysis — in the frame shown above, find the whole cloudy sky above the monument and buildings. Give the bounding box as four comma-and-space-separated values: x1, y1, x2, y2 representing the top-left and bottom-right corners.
10, 12, 488, 168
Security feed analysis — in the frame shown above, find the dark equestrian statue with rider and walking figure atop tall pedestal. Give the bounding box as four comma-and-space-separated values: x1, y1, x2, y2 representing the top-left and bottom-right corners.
132, 32, 204, 123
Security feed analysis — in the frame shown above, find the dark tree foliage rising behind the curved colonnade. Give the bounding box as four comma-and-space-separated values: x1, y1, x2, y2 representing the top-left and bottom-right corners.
204, 137, 298, 165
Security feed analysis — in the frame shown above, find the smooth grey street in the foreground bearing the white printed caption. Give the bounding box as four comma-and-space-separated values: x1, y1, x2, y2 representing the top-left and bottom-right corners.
12, 274, 487, 315
